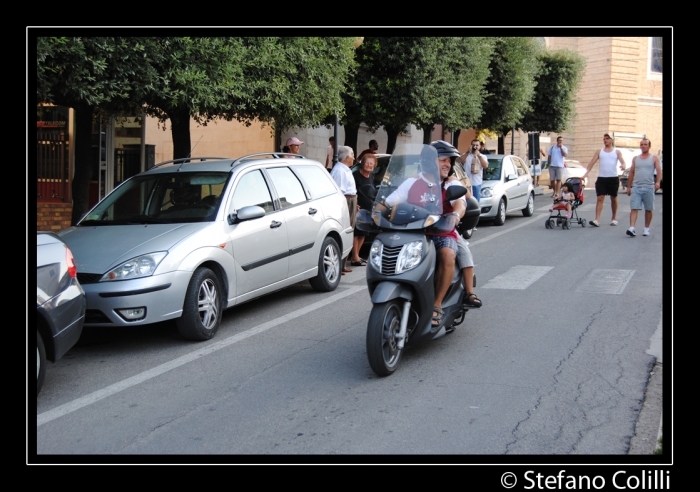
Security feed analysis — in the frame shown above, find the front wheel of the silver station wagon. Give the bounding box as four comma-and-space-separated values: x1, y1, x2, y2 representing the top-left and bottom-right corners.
175, 267, 223, 341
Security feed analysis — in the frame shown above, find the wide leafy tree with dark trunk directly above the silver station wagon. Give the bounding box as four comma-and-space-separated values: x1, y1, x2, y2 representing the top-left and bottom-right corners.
146, 37, 354, 158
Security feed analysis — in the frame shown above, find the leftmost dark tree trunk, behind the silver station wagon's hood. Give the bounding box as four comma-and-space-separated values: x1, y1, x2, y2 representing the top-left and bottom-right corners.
71, 105, 95, 225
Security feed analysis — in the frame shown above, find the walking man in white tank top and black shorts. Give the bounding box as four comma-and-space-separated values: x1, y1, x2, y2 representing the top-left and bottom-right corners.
581, 133, 626, 227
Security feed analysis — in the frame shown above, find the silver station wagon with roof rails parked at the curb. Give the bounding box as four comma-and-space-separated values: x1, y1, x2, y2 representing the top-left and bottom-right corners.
60, 153, 353, 340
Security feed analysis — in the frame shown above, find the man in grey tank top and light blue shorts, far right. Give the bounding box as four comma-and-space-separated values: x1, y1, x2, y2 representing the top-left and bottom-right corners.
627, 138, 661, 237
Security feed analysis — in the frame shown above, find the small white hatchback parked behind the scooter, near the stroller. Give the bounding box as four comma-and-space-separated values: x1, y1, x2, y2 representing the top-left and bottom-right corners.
479, 154, 535, 225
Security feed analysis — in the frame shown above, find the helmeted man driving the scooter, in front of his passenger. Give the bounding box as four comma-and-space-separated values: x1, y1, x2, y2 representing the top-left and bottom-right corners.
385, 141, 467, 326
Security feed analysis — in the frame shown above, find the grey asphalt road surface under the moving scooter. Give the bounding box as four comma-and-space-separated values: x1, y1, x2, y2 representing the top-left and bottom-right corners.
34, 186, 663, 463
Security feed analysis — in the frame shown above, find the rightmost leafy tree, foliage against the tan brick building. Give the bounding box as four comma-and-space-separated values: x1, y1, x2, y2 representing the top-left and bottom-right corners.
517, 50, 586, 133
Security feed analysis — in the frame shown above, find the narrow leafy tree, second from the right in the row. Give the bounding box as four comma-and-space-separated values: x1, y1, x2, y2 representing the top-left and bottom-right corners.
476, 37, 543, 154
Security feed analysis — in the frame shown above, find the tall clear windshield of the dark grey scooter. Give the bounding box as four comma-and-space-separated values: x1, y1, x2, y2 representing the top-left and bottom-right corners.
374, 144, 442, 218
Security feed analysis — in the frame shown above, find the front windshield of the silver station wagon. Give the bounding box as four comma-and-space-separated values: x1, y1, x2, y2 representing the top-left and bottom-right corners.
78, 172, 230, 226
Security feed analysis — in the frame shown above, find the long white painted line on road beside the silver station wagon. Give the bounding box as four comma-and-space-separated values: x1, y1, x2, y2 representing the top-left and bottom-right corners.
36, 285, 367, 427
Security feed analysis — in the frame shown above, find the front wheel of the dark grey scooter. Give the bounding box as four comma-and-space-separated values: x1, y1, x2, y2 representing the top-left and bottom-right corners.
367, 300, 403, 376
